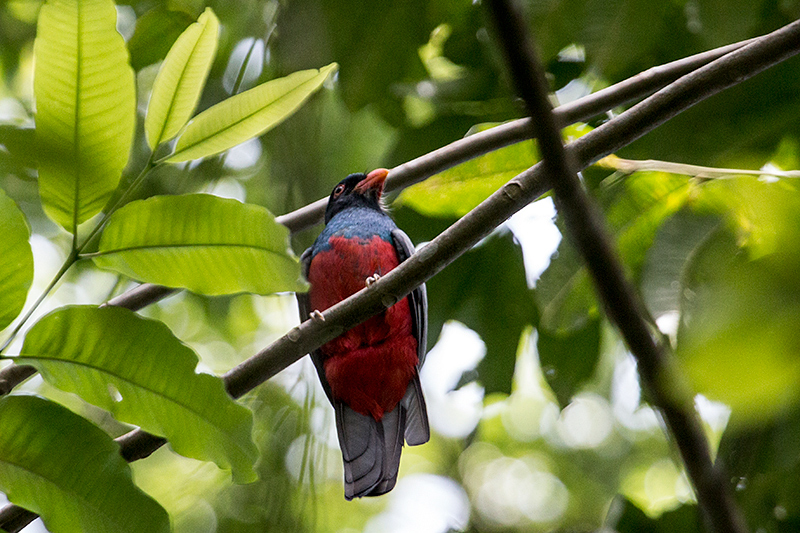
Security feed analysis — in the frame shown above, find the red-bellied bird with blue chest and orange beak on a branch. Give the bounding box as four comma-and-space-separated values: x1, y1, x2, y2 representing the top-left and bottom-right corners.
298, 169, 430, 500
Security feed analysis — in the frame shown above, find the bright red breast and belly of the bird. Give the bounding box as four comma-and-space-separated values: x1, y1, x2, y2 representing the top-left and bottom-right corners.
308, 236, 418, 420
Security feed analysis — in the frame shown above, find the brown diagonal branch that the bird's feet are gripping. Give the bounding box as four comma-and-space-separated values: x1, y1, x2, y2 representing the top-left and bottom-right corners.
0, 23, 800, 532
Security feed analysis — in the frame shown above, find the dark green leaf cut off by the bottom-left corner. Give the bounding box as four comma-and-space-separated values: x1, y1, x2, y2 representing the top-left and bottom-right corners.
0, 396, 170, 533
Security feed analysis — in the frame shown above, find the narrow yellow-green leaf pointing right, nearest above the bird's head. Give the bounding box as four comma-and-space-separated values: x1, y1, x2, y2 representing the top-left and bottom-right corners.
167, 63, 338, 162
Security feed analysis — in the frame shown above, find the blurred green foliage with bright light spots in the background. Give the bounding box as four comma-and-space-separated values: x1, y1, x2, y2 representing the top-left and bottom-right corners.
0, 0, 800, 533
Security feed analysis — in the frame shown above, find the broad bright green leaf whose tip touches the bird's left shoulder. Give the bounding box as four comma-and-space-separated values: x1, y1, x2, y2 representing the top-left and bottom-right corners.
92, 194, 305, 295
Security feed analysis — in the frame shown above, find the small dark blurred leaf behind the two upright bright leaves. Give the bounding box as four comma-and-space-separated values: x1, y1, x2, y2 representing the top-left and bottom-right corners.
128, 5, 194, 71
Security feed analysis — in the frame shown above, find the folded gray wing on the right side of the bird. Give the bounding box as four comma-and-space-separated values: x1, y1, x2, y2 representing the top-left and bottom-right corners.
392, 229, 431, 446
